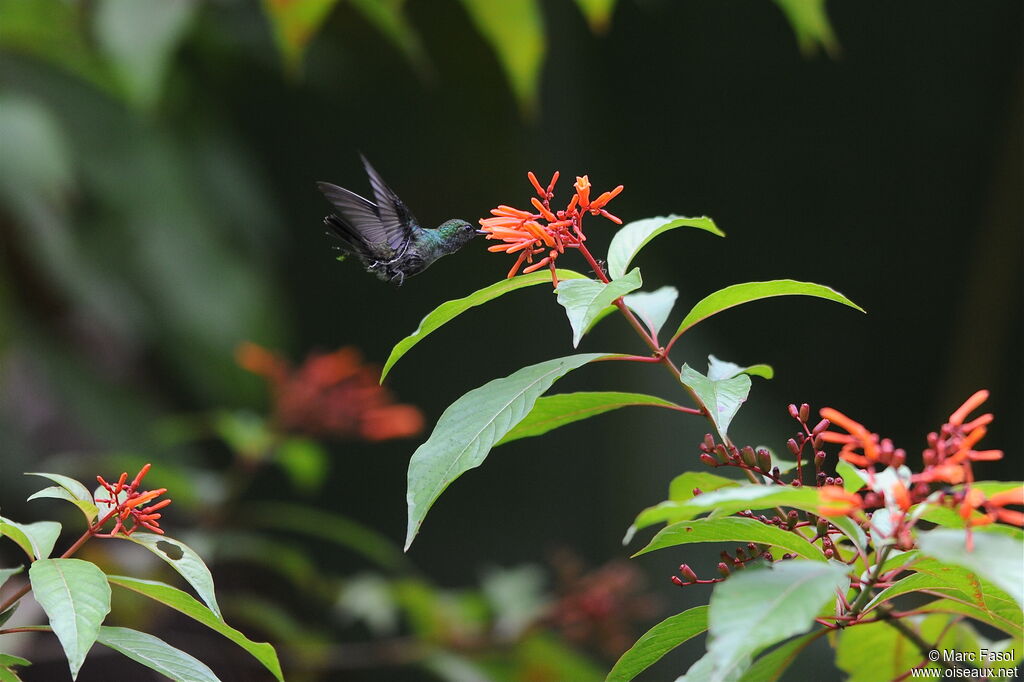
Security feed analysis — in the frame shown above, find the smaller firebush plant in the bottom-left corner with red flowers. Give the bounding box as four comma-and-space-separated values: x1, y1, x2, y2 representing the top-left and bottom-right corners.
0, 464, 284, 682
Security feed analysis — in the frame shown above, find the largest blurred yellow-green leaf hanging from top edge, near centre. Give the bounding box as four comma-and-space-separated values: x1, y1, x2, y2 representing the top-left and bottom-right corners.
462, 0, 545, 112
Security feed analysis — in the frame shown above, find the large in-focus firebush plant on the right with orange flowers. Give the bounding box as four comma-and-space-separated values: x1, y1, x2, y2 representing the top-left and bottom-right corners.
381, 173, 1024, 682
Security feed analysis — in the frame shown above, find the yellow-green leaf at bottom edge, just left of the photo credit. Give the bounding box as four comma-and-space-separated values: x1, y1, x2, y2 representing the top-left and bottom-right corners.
836, 623, 922, 682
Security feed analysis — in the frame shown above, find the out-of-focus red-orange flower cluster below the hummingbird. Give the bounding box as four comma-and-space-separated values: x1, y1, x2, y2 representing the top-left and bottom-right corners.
237, 343, 423, 441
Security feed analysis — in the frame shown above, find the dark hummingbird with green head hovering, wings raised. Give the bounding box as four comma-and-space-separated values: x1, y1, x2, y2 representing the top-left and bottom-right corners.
316, 155, 477, 286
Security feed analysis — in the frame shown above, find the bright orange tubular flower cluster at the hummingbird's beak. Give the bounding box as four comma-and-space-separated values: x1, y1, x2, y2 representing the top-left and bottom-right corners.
480, 171, 623, 286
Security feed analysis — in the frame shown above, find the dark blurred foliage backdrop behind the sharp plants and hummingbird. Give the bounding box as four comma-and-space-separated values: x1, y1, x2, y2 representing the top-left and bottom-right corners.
0, 0, 1024, 680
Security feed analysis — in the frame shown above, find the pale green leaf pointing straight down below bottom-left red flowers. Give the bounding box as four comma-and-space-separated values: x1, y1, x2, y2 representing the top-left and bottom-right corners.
29, 559, 111, 679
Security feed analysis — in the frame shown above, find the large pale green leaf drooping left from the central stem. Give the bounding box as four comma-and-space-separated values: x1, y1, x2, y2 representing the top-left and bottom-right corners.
406, 353, 604, 550
